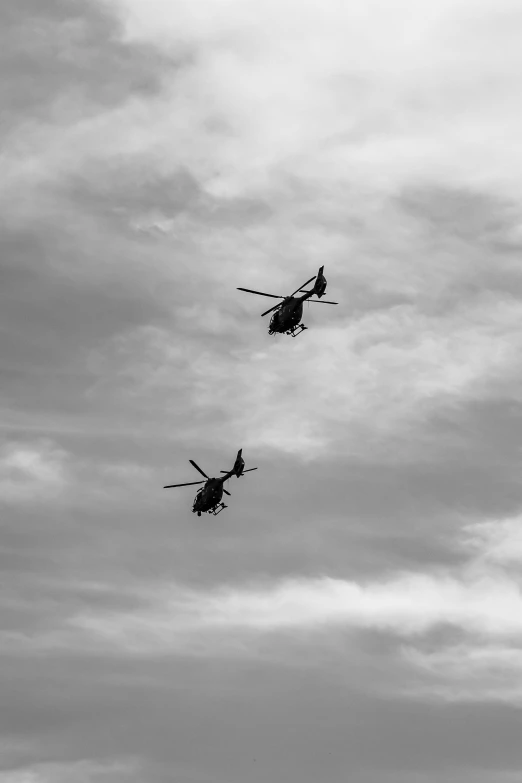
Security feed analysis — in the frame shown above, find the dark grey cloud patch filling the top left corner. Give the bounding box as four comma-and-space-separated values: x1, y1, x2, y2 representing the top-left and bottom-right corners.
0, 0, 174, 132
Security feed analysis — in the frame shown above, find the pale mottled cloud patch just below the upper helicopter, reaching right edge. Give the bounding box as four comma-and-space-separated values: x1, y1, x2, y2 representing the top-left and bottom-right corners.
234, 296, 522, 453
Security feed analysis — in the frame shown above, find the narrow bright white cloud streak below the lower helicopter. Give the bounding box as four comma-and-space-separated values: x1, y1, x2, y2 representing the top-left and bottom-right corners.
63, 573, 522, 655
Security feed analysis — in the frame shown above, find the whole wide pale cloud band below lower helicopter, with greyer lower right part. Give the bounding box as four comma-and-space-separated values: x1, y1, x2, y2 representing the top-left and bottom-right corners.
0, 508, 506, 716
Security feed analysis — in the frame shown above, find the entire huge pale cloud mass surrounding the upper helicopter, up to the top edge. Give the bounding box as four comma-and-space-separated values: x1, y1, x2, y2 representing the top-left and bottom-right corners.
4, 0, 520, 472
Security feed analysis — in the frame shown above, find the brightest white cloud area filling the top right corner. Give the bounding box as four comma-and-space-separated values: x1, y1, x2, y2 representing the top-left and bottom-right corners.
84, 0, 522, 202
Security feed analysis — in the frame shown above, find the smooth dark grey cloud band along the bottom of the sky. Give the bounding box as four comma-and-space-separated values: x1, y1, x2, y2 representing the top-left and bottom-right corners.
0, 659, 521, 783
